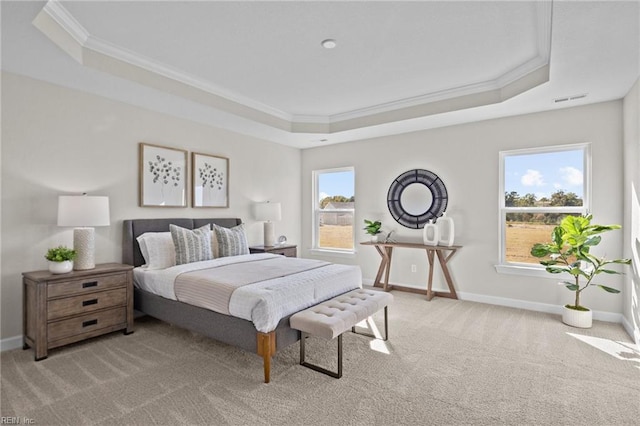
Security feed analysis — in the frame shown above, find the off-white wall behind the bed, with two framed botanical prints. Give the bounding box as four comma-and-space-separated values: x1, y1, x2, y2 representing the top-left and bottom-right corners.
0, 73, 301, 339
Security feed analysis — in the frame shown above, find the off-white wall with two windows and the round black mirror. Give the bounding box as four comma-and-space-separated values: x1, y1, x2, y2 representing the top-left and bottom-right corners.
302, 101, 623, 320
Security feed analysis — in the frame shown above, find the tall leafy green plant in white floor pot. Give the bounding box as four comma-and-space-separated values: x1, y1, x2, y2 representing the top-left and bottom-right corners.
531, 215, 631, 328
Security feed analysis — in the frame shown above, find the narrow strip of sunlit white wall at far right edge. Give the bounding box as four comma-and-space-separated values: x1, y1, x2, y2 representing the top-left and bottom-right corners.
623, 75, 640, 345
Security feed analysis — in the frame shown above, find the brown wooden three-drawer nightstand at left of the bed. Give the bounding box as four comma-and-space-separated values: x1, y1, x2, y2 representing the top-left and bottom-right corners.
22, 263, 133, 361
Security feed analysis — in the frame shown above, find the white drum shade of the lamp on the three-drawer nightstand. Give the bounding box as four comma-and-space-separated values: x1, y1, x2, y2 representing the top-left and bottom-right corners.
58, 195, 109, 227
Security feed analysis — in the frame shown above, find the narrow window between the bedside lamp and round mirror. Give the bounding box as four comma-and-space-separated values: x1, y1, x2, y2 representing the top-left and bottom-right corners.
313, 167, 355, 252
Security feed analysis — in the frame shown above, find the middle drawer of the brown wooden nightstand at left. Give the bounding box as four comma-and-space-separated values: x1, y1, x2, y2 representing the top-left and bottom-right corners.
47, 288, 127, 320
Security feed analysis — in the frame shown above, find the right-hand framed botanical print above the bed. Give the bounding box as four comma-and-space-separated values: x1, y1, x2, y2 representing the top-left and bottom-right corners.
191, 152, 229, 208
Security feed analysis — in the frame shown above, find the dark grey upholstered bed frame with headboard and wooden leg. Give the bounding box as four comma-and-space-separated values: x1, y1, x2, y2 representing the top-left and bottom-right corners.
122, 218, 361, 383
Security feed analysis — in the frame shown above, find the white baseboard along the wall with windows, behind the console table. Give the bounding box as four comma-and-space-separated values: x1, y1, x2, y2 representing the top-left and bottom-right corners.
362, 279, 633, 324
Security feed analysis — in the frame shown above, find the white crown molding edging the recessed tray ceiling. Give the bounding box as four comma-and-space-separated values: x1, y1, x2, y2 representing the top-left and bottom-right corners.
33, 0, 553, 134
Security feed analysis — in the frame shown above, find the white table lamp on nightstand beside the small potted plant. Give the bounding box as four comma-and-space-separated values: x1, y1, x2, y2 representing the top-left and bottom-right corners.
58, 195, 109, 271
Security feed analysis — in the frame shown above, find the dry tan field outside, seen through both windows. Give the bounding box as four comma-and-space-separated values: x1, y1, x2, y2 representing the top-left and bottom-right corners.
320, 222, 554, 264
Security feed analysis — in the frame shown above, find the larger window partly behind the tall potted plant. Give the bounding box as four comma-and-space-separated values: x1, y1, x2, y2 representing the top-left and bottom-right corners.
499, 144, 591, 267
